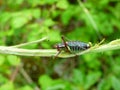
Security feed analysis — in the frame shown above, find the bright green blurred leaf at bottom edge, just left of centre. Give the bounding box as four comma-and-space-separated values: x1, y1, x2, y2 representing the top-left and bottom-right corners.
39, 75, 71, 90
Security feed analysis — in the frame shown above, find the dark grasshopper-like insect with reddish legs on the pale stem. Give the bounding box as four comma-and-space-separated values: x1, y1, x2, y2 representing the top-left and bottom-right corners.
55, 36, 91, 56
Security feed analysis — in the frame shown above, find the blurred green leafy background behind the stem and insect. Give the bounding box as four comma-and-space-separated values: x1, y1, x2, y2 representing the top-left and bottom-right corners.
0, 0, 120, 90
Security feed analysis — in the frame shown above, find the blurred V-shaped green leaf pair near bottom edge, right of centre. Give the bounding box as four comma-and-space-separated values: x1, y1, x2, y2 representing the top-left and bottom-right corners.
73, 70, 101, 90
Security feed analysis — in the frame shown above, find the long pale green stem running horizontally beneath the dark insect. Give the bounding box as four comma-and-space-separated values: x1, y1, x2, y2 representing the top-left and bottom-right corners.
0, 39, 120, 58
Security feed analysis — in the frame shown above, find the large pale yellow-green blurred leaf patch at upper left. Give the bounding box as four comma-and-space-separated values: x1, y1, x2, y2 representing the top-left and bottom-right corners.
11, 9, 40, 28
